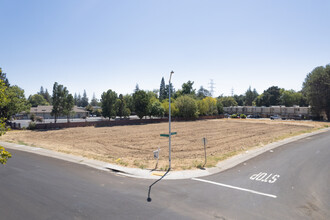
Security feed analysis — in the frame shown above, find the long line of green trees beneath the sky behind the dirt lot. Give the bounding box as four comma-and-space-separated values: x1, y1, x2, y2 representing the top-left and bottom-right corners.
0, 62, 330, 120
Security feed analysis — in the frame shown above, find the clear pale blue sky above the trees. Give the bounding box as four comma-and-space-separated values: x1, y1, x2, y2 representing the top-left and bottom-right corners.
0, 0, 330, 99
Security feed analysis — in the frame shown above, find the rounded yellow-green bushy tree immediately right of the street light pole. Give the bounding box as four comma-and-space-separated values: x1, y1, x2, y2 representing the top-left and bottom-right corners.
175, 95, 198, 119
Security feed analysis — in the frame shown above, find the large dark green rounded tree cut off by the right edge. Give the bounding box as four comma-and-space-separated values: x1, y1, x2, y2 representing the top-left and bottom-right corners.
303, 64, 330, 120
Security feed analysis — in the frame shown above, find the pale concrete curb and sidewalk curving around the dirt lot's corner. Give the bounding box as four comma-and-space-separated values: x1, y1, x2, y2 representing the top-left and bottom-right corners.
0, 128, 330, 180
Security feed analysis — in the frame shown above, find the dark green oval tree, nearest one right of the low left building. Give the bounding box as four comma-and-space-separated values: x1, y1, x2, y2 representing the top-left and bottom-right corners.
101, 89, 117, 120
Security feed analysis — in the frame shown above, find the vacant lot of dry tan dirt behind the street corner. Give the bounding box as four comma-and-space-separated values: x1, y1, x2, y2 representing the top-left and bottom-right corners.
0, 119, 329, 170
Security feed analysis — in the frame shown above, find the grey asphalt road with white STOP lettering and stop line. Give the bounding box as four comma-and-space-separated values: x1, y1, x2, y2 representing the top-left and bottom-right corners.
0, 132, 330, 220
